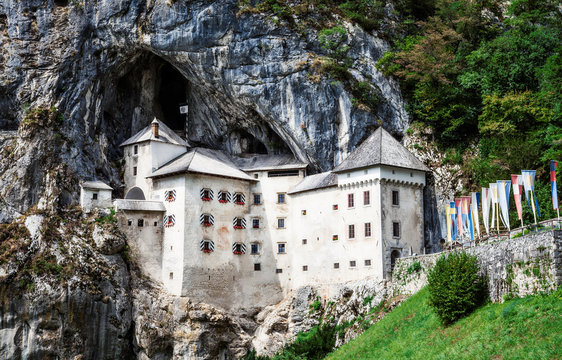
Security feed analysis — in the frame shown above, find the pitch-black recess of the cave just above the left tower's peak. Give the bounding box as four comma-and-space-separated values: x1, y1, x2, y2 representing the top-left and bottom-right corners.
155, 63, 188, 131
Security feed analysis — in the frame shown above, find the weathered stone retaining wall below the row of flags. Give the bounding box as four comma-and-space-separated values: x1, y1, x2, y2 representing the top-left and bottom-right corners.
392, 230, 562, 302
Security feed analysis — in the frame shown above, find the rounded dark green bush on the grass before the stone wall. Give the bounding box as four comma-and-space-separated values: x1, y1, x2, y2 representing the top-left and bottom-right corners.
428, 252, 488, 325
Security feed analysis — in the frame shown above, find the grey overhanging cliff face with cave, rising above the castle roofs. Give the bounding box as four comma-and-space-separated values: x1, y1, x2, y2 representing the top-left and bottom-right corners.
0, 0, 408, 221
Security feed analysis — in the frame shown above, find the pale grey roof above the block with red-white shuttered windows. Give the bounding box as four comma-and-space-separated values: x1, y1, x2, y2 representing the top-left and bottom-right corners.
148, 148, 256, 181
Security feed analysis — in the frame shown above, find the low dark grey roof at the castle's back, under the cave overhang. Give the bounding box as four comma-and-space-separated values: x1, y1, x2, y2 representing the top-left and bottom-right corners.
232, 154, 308, 171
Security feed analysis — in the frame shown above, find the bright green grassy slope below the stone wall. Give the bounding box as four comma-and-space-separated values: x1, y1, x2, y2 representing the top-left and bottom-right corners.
326, 288, 562, 360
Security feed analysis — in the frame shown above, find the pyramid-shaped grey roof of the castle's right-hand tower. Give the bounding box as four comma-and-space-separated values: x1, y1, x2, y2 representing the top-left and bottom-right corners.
333, 126, 429, 173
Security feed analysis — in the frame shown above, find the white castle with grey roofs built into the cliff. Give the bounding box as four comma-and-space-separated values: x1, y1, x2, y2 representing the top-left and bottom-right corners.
82, 119, 429, 308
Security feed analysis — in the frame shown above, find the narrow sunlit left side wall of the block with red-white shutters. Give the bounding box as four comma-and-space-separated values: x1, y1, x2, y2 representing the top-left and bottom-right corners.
151, 175, 189, 295
